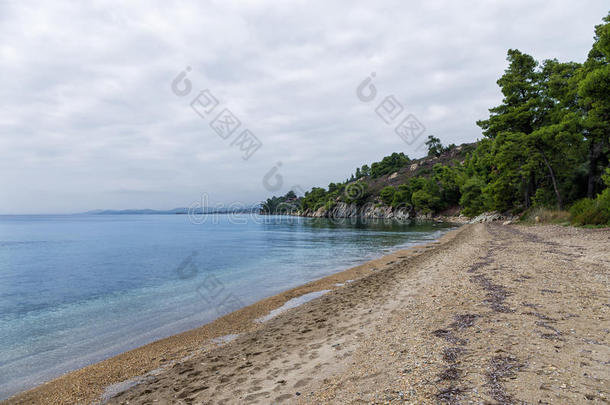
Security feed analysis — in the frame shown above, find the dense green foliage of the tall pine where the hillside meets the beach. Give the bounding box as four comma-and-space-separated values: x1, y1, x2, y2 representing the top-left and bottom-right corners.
478, 49, 583, 211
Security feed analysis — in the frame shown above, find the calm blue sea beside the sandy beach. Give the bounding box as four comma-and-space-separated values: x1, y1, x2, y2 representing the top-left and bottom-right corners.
0, 214, 450, 399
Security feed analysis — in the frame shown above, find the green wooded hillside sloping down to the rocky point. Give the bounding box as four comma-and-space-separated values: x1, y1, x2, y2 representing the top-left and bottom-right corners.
262, 13, 610, 225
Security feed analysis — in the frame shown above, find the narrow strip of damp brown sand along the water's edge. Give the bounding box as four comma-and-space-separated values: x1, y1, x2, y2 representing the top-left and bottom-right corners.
0, 222, 462, 404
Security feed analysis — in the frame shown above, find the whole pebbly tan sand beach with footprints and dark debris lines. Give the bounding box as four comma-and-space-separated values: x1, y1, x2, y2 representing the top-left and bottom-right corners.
7, 223, 610, 404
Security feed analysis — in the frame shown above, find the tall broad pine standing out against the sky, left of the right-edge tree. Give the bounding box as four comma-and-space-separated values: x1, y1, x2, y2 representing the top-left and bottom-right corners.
477, 49, 577, 208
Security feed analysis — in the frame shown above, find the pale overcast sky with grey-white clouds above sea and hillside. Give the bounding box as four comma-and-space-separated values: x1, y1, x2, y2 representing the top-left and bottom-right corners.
0, 0, 608, 214
